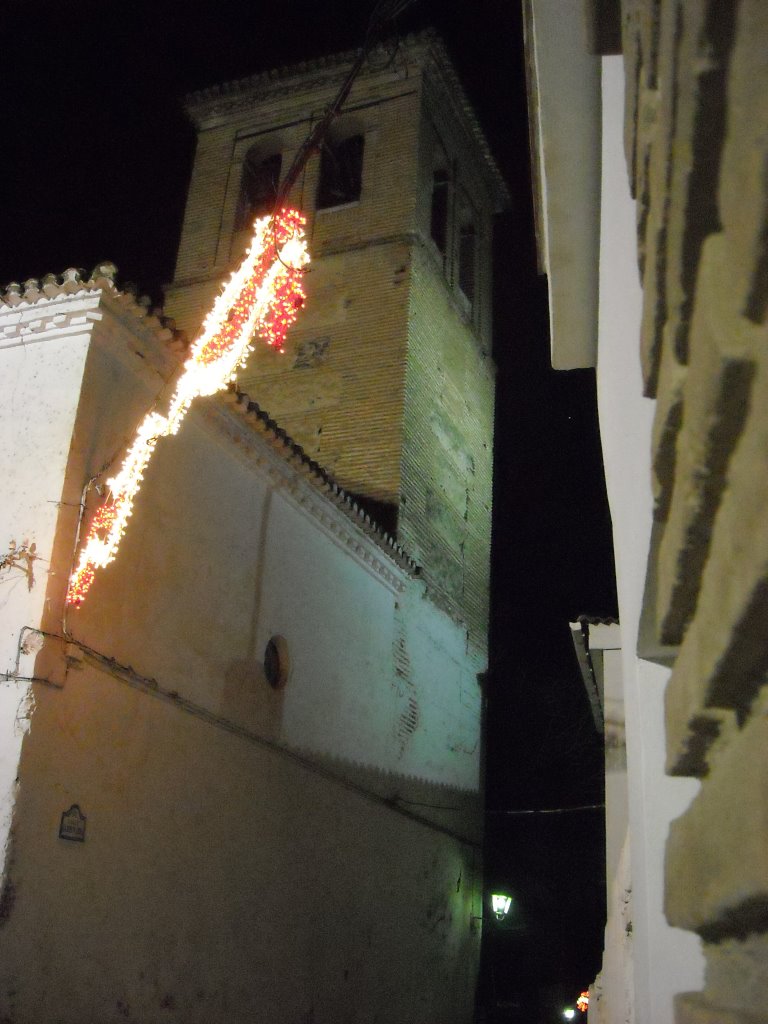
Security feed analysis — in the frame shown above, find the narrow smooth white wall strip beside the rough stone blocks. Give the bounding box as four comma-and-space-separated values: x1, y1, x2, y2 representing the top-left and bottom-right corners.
597, 57, 703, 1024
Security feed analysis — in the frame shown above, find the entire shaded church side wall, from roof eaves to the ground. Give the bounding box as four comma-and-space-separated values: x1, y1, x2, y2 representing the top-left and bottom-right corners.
0, 290, 484, 1024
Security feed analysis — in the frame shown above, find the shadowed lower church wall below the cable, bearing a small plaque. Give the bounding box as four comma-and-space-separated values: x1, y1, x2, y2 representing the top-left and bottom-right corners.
0, 667, 480, 1024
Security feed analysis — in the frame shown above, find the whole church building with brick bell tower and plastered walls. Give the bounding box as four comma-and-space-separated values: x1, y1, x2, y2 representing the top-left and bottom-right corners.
0, 37, 503, 1024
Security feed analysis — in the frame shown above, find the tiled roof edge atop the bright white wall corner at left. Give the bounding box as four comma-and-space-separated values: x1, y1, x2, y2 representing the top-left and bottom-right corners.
0, 260, 187, 350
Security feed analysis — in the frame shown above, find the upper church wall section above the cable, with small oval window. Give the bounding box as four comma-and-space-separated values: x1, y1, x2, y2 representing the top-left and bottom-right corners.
70, 380, 483, 791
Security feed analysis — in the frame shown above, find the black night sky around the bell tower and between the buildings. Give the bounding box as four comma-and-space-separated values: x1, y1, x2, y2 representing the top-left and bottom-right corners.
0, 0, 615, 1021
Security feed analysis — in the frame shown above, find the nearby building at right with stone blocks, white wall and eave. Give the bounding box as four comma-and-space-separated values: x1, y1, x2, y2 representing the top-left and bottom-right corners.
526, 0, 768, 1024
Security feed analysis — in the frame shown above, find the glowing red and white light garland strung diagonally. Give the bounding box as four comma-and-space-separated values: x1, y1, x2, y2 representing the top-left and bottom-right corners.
67, 210, 309, 606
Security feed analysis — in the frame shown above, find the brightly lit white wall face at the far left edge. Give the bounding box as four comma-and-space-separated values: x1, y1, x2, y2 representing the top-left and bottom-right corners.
0, 297, 98, 876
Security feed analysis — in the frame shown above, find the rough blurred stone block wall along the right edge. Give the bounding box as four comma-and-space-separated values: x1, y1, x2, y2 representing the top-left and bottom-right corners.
622, 0, 768, 1024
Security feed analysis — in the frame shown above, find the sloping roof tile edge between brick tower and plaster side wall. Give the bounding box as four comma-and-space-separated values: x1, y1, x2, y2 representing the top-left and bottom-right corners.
226, 383, 419, 575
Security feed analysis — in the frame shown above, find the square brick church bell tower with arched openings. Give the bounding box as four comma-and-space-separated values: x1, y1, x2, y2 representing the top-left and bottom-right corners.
166, 33, 508, 650
